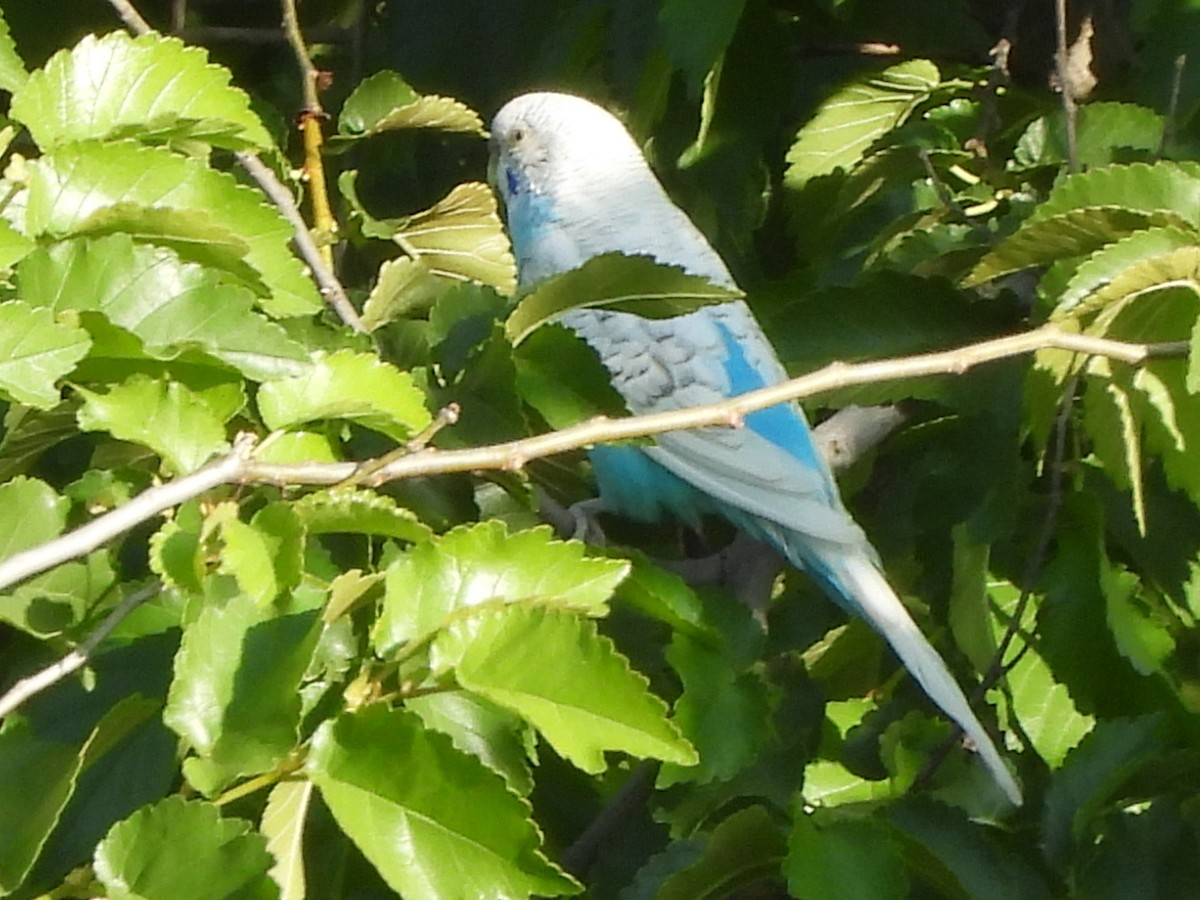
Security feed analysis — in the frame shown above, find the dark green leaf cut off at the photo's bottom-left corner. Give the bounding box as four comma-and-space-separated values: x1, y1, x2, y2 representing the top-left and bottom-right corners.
0, 716, 83, 895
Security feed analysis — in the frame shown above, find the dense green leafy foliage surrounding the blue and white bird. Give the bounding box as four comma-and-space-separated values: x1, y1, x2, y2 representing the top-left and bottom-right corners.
0, 0, 1200, 900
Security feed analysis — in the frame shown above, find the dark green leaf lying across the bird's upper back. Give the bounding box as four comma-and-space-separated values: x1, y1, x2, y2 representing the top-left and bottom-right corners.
504, 253, 742, 344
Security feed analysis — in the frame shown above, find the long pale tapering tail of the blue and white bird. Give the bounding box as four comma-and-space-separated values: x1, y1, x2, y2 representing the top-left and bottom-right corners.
822, 553, 1021, 805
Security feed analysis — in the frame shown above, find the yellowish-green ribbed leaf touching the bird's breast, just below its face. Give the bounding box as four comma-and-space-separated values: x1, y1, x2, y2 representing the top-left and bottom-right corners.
391, 181, 517, 295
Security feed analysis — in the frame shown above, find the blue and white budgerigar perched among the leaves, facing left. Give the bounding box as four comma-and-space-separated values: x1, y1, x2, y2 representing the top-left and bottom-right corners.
492, 92, 1021, 803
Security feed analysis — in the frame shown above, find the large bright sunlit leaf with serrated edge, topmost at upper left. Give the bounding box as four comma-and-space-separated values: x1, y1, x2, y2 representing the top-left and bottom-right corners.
12, 31, 274, 150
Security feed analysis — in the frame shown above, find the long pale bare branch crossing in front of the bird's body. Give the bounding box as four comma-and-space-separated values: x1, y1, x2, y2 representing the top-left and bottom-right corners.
0, 325, 1189, 590
